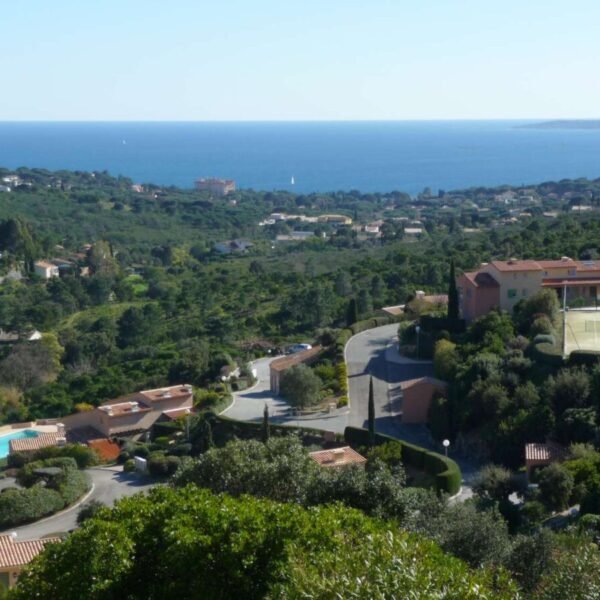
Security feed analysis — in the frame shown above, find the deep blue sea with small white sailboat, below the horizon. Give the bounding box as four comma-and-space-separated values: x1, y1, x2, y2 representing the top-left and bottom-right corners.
0, 121, 600, 194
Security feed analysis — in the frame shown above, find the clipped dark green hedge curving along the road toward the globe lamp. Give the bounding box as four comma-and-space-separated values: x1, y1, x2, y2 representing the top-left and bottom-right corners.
344, 427, 462, 496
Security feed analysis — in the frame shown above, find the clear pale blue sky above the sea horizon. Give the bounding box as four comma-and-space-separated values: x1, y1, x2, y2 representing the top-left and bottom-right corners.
0, 0, 600, 121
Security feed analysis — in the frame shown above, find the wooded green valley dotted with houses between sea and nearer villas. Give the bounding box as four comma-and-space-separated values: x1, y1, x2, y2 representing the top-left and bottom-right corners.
0, 163, 600, 421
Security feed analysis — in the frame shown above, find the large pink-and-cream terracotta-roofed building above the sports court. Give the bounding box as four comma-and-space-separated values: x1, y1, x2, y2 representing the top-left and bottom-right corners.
457, 256, 600, 321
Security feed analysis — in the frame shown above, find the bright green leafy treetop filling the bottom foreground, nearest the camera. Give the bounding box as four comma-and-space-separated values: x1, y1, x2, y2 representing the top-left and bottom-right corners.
11, 485, 517, 600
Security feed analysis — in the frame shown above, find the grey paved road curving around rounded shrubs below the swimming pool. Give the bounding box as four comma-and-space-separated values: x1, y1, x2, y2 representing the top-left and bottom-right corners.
3, 467, 155, 540
